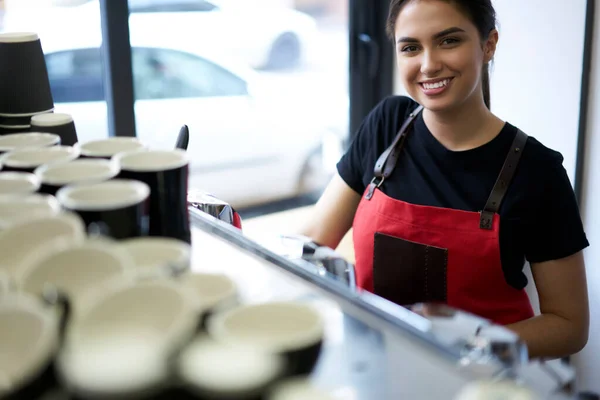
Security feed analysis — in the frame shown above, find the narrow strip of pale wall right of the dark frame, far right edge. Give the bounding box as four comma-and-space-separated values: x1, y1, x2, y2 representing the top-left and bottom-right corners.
574, 0, 600, 392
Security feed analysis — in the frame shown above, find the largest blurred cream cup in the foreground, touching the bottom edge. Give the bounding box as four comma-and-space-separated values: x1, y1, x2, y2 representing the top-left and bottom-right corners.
57, 279, 197, 398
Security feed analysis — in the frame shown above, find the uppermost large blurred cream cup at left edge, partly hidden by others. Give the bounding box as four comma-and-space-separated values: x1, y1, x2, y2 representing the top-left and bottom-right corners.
0, 212, 85, 277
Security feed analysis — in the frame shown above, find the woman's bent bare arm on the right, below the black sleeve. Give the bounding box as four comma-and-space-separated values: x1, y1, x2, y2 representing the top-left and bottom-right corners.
507, 251, 589, 358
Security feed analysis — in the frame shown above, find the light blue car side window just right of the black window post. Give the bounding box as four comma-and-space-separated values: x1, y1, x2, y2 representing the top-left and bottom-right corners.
132, 48, 248, 100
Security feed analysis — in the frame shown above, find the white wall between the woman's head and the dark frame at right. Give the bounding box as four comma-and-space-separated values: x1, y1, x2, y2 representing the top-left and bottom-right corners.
491, 0, 586, 182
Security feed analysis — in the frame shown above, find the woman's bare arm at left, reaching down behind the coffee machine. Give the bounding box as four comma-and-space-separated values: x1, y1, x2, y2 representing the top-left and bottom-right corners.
300, 174, 361, 249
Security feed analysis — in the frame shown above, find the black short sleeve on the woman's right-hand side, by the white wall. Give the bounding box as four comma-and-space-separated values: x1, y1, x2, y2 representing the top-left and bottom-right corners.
522, 155, 589, 263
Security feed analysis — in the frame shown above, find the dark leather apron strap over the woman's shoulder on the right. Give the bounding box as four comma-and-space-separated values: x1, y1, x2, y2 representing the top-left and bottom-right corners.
479, 129, 527, 230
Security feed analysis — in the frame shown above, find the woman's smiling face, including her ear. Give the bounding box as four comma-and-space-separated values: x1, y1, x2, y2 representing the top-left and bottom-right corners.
395, 0, 498, 111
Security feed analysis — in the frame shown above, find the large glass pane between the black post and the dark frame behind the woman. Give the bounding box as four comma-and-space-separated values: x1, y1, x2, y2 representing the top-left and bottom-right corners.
129, 0, 349, 215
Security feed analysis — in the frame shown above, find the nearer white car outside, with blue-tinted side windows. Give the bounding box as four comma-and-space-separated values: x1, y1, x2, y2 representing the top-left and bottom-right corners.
42, 27, 340, 207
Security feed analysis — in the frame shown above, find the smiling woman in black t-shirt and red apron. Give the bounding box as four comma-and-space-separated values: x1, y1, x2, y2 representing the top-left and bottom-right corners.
302, 0, 589, 357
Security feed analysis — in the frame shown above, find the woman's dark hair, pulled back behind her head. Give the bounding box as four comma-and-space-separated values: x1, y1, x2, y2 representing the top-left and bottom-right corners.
385, 0, 496, 108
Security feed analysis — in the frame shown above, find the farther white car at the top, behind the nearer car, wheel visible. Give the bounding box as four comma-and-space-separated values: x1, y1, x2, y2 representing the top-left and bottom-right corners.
4, 0, 318, 68
